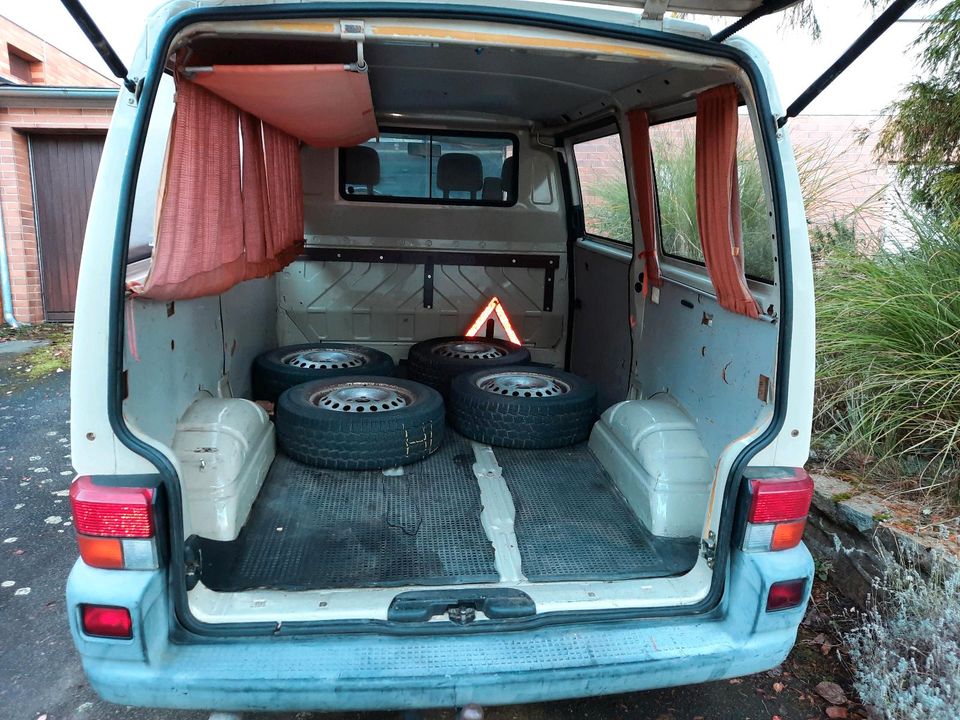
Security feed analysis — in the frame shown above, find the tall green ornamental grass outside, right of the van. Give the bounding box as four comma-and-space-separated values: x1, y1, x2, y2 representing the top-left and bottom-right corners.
816, 205, 960, 501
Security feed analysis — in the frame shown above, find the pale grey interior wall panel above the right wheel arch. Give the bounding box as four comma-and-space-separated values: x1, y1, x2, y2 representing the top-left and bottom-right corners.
634, 279, 777, 461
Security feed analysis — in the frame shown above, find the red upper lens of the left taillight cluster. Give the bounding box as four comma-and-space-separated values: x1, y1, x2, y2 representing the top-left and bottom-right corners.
70, 477, 153, 538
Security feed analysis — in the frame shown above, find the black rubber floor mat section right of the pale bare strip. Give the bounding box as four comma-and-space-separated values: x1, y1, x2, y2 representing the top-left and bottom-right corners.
494, 443, 698, 581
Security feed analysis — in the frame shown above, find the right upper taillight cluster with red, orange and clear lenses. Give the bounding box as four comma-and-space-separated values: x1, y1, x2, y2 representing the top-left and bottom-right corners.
740, 468, 813, 552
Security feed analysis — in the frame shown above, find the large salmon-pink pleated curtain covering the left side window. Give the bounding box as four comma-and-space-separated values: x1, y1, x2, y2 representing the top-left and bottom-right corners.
131, 77, 303, 300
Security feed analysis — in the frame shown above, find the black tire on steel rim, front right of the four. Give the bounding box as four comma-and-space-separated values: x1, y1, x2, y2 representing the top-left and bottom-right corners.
449, 365, 597, 449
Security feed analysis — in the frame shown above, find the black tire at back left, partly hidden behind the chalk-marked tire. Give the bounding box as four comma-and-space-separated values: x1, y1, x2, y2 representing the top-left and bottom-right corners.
253, 342, 395, 402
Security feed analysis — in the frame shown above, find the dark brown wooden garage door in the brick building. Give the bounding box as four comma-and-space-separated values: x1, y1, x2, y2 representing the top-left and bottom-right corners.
30, 135, 103, 321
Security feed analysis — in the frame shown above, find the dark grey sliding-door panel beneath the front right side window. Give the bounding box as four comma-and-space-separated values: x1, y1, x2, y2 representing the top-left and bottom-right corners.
570, 240, 632, 412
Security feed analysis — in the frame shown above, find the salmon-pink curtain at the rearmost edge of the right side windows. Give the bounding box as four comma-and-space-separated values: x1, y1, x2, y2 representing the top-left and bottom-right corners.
696, 85, 760, 318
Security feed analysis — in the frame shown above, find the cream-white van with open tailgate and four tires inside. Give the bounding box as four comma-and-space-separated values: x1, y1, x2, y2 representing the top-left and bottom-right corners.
67, 0, 848, 711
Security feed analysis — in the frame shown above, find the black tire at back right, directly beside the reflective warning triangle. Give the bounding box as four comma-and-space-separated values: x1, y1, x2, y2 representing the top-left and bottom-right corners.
407, 336, 530, 398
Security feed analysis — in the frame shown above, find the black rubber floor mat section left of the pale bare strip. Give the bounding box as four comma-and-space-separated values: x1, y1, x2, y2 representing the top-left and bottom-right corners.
197, 433, 498, 592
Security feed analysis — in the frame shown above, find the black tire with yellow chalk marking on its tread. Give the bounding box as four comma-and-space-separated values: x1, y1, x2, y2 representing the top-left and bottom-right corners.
276, 375, 444, 470
